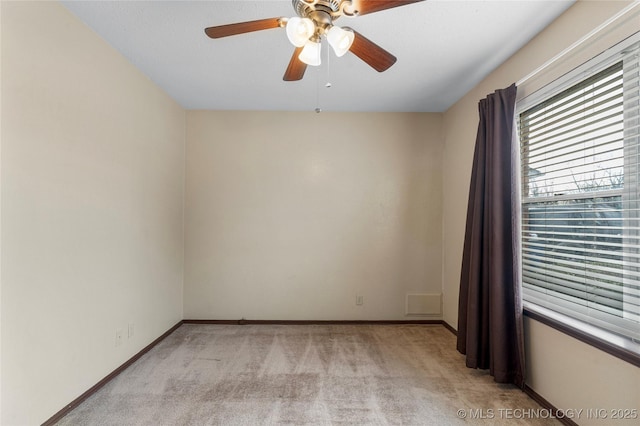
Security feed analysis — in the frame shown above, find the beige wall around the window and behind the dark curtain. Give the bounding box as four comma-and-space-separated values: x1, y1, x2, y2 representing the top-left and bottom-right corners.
443, 1, 640, 424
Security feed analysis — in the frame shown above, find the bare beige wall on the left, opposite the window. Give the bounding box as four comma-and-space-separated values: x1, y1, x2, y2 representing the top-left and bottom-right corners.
0, 1, 185, 425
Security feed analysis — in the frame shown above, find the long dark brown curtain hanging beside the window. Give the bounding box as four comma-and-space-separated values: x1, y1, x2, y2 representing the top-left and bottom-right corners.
457, 84, 524, 387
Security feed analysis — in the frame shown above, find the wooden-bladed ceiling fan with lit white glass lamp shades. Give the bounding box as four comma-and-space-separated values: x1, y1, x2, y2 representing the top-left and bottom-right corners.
204, 0, 424, 81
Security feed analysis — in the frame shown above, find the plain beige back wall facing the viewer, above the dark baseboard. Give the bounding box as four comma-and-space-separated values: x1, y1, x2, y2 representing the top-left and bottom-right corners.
184, 111, 442, 320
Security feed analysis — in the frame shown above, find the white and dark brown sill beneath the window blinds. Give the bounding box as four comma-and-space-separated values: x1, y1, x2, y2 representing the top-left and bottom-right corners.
524, 302, 640, 367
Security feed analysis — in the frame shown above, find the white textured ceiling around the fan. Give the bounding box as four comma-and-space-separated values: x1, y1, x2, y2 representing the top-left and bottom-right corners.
62, 0, 574, 112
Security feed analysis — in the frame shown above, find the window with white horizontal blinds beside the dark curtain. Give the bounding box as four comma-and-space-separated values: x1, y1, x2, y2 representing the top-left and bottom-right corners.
517, 35, 640, 339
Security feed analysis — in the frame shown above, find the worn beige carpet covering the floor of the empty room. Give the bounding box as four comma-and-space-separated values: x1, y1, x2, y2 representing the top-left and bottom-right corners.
58, 324, 559, 425
